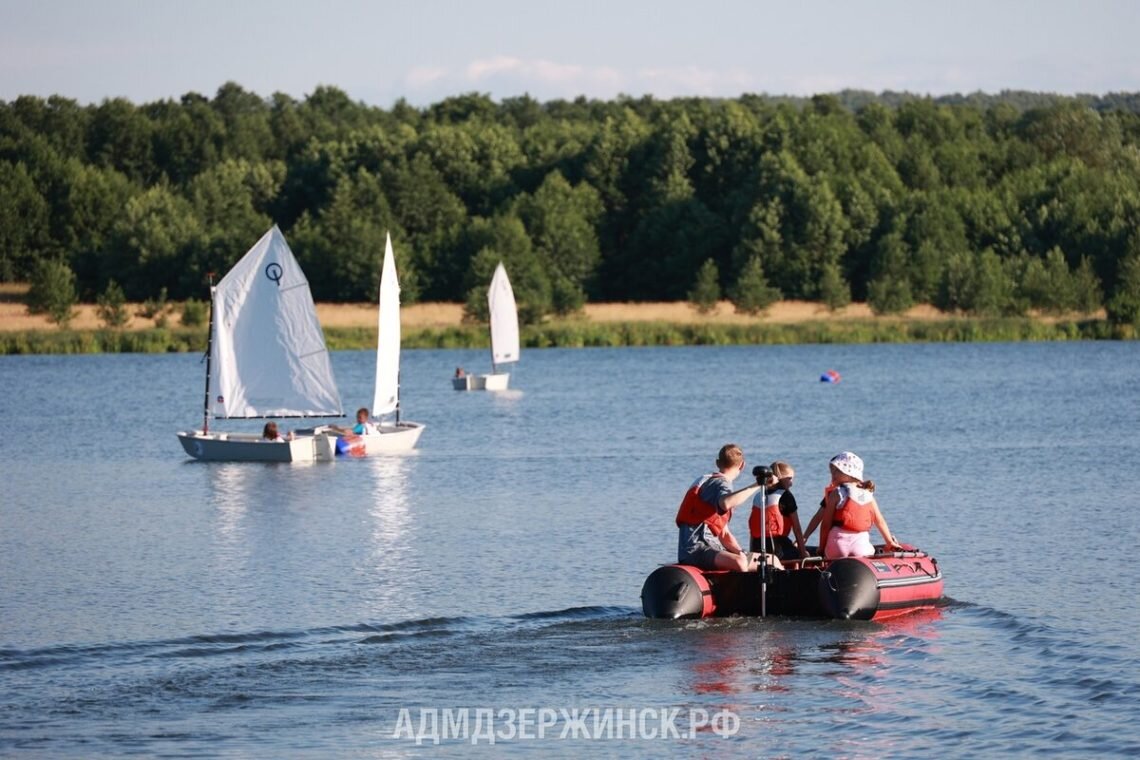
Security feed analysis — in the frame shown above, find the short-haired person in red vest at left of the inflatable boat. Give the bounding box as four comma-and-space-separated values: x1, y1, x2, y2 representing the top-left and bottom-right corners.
676, 443, 783, 572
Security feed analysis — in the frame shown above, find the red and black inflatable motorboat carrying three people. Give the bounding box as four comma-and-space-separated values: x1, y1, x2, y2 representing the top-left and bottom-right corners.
642, 546, 943, 621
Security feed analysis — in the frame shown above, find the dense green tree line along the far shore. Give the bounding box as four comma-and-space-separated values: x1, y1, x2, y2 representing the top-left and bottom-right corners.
0, 82, 1140, 324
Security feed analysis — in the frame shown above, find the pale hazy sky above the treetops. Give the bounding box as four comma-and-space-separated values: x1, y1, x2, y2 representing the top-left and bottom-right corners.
0, 0, 1140, 108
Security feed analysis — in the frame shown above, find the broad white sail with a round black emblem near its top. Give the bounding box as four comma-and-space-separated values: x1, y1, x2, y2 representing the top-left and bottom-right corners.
209, 226, 343, 419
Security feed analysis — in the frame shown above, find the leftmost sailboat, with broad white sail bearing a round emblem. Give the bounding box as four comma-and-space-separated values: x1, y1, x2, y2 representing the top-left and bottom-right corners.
178, 224, 344, 461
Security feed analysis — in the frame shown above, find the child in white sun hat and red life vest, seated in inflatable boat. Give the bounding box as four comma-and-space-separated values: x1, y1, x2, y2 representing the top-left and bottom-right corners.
813, 451, 902, 559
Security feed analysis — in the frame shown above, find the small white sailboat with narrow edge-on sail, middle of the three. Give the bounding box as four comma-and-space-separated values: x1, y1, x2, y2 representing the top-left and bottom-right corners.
332, 234, 424, 453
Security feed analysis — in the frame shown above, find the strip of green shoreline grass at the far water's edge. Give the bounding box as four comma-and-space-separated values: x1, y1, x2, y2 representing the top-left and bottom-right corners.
0, 317, 1121, 356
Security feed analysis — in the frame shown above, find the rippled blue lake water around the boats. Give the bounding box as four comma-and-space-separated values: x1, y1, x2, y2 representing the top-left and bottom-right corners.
0, 343, 1140, 758
